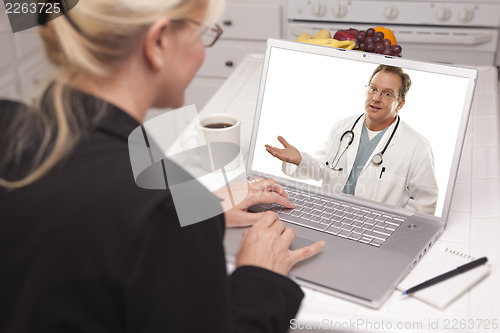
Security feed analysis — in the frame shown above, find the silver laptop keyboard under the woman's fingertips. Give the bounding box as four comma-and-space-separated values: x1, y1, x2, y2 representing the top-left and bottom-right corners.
254, 186, 405, 247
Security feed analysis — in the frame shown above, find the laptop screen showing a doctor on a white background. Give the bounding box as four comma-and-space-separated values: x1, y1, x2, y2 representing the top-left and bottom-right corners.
249, 40, 476, 217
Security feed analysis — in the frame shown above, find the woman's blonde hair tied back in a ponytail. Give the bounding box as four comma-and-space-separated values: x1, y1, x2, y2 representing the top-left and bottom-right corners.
0, 0, 224, 188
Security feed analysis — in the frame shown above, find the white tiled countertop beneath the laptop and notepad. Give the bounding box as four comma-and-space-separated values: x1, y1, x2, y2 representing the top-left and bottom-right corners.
200, 54, 500, 332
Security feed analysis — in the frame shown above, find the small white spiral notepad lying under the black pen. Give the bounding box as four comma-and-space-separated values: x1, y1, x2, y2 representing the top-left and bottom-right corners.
397, 246, 490, 309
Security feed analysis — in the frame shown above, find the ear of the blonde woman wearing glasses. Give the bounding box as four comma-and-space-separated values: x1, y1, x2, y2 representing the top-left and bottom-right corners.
144, 19, 172, 70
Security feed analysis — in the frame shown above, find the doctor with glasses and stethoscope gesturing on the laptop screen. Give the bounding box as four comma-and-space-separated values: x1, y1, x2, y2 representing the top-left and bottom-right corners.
266, 65, 438, 214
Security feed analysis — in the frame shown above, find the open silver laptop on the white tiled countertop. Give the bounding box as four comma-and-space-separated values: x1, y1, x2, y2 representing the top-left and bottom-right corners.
225, 39, 477, 308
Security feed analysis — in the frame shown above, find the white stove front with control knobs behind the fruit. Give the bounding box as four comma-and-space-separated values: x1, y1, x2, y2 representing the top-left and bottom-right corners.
287, 0, 500, 66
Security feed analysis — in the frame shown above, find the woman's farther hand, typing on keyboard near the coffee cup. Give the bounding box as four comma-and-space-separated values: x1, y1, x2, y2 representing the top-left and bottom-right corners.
221, 177, 295, 227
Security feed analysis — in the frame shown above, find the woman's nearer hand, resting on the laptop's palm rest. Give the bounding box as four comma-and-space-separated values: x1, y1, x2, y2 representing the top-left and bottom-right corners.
236, 211, 325, 275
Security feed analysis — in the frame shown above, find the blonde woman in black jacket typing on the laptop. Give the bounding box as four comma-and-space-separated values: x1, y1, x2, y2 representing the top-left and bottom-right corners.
0, 0, 324, 333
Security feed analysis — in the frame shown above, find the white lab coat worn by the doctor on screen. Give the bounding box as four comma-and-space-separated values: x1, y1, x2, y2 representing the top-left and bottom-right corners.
283, 115, 438, 214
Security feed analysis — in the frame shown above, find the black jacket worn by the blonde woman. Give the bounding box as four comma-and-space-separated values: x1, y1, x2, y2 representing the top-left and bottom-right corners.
0, 95, 303, 333
